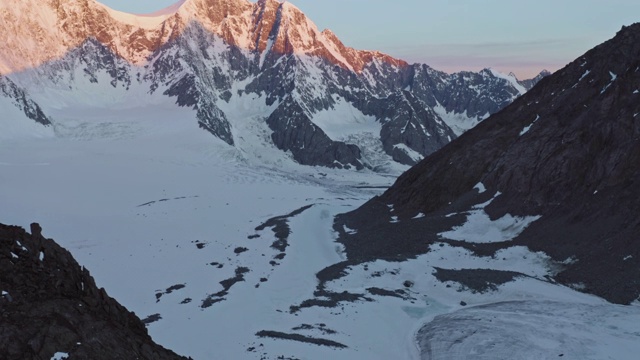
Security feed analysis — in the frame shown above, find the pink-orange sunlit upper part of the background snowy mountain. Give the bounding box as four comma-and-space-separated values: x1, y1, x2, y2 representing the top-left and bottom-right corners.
0, 0, 406, 74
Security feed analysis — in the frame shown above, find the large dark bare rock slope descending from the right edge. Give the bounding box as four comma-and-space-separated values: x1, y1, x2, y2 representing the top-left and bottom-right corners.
335, 24, 640, 304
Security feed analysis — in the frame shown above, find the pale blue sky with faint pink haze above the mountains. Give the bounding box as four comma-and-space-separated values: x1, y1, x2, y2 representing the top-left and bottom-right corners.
99, 0, 640, 79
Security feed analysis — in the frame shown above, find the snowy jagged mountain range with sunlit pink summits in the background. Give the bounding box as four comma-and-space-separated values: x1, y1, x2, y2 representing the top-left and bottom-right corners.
0, 0, 537, 169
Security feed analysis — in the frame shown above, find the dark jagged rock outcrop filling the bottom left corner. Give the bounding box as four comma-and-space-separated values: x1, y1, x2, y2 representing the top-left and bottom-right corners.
0, 224, 184, 360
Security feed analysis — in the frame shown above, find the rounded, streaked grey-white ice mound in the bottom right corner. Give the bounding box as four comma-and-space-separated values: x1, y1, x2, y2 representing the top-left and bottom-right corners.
418, 300, 640, 360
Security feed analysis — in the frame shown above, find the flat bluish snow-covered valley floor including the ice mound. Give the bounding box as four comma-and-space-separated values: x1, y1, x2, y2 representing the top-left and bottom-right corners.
0, 109, 640, 359
